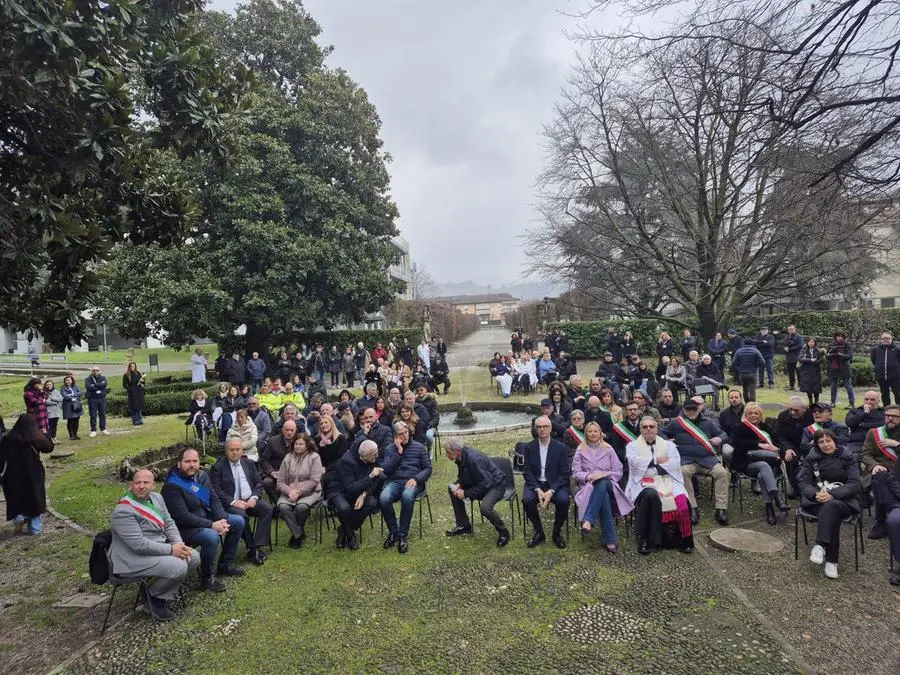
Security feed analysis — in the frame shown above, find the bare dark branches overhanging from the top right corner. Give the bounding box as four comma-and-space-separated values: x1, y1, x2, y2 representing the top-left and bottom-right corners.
581, 0, 900, 185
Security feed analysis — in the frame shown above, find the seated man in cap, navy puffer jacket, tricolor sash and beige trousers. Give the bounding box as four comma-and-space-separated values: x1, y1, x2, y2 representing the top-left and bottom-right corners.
661, 399, 729, 525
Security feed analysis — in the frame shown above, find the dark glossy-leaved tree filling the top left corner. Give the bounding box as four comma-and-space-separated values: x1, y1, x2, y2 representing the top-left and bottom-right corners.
0, 0, 244, 346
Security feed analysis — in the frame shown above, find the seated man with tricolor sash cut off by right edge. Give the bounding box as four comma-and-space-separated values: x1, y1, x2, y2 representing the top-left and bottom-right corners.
860, 405, 900, 539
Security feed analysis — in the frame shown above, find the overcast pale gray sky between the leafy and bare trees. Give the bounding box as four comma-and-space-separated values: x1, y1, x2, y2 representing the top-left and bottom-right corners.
211, 0, 597, 285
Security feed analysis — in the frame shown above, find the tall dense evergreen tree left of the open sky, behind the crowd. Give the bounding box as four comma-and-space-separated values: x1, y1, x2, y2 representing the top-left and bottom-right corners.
96, 0, 398, 352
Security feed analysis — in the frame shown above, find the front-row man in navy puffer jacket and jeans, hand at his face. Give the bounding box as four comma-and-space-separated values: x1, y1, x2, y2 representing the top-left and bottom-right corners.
378, 420, 431, 553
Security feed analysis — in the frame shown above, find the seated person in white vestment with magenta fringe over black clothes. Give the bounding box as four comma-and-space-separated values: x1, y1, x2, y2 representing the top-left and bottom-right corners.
625, 417, 694, 555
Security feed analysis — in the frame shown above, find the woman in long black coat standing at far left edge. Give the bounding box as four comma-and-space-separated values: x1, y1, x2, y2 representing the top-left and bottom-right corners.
0, 415, 53, 535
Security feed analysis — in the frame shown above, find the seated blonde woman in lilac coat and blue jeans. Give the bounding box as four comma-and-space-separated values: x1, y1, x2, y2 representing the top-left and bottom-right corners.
572, 422, 634, 553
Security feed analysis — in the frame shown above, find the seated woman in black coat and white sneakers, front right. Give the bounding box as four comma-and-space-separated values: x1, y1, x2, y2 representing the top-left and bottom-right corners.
797, 429, 860, 579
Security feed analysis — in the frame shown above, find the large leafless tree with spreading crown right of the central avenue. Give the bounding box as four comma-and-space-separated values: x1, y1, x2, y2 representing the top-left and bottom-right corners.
529, 25, 878, 336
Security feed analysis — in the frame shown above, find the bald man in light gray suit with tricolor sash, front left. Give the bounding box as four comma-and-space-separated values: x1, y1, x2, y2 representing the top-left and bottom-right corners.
109, 469, 200, 621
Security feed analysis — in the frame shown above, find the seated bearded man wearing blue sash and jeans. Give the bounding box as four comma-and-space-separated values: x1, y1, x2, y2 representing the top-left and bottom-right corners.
162, 448, 244, 593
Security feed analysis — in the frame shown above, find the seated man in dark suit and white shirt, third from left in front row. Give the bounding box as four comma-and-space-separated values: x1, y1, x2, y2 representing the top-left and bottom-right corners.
209, 438, 275, 565
